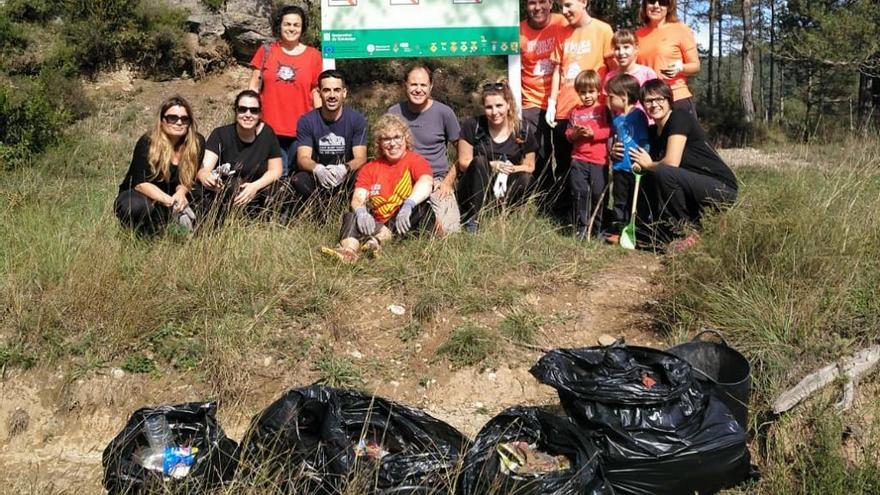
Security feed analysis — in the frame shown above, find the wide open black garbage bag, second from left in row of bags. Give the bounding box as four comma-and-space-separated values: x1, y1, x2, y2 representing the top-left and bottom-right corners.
242, 385, 469, 494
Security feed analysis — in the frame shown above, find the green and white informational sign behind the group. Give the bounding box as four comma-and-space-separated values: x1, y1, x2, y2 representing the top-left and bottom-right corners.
321, 0, 519, 59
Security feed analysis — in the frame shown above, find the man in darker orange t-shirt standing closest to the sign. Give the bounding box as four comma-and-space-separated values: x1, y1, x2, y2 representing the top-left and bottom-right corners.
519, 0, 571, 202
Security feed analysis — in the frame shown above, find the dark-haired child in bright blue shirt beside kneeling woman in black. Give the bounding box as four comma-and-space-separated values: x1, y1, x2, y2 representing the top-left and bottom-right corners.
605, 74, 650, 249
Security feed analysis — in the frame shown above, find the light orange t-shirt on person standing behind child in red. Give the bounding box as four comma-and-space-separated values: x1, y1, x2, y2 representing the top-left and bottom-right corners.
550, 18, 614, 120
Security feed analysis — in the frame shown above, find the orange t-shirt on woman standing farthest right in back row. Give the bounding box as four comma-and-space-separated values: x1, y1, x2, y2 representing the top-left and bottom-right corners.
636, 22, 697, 100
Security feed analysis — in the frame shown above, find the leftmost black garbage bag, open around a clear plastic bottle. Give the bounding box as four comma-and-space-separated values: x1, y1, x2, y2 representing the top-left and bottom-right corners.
101, 402, 238, 495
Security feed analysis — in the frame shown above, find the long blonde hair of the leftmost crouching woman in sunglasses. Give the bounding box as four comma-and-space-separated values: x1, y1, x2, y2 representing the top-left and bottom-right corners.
147, 95, 200, 188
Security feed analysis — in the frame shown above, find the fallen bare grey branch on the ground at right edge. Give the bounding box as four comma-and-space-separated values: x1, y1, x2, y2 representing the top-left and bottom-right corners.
773, 345, 880, 414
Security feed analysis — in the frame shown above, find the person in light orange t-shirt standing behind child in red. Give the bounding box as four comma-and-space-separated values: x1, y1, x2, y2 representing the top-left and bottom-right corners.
545, 0, 614, 221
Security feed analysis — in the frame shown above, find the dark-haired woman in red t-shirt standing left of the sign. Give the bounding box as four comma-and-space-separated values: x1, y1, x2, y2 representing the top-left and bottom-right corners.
249, 5, 323, 176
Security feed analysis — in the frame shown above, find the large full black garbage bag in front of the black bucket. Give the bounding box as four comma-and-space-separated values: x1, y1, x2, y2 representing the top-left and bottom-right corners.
531, 343, 750, 495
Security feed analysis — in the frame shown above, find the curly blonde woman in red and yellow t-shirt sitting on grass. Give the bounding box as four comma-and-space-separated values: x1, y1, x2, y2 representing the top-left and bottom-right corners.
321, 114, 434, 263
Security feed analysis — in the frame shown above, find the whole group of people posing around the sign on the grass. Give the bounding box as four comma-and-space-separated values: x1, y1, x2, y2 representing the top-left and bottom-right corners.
115, 0, 737, 256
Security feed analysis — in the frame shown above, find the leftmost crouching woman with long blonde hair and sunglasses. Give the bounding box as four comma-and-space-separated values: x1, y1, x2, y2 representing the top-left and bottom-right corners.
114, 96, 205, 235
